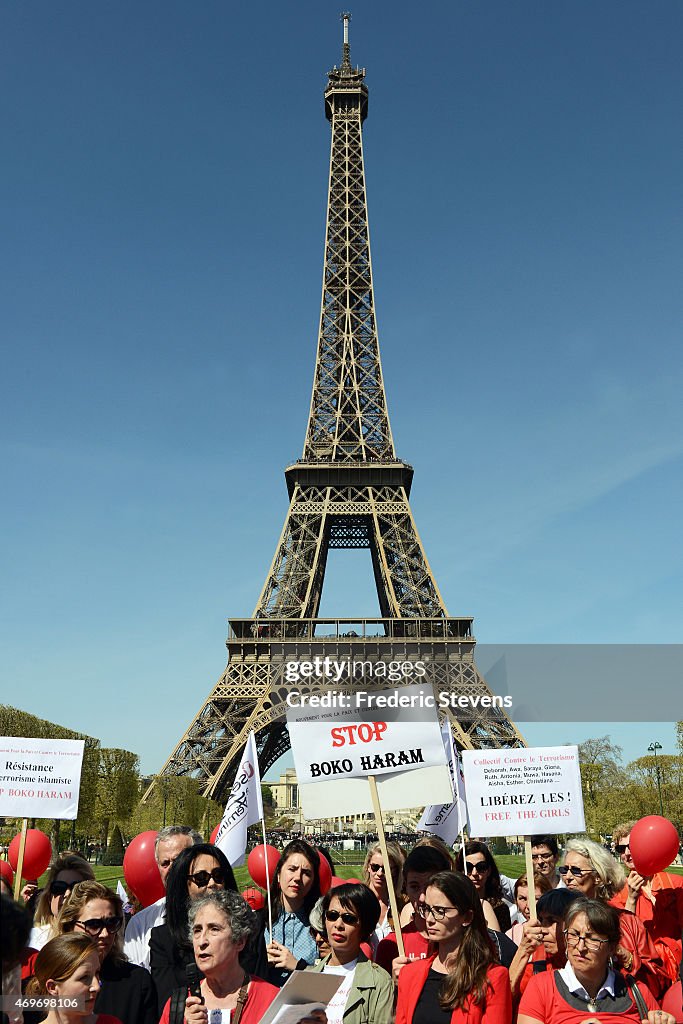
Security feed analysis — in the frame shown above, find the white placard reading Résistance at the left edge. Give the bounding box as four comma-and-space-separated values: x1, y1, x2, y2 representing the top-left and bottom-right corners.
0, 736, 85, 821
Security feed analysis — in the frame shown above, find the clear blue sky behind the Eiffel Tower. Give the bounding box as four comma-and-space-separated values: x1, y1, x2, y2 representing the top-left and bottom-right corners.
0, 0, 683, 770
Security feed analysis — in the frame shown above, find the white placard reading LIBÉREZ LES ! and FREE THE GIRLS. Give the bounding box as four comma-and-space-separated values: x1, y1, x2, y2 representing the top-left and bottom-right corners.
462, 746, 586, 836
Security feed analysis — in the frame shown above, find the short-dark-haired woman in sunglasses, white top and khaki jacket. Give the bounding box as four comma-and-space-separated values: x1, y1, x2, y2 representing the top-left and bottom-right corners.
307, 882, 393, 1024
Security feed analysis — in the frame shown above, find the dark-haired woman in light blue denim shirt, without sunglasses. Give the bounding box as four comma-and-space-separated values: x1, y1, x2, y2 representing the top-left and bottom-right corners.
264, 839, 321, 987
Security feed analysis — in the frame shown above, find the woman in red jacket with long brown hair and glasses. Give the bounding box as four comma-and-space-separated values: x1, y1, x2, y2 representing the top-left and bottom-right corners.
396, 871, 512, 1024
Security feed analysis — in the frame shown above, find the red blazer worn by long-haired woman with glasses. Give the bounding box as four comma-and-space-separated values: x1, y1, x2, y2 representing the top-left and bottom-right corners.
396, 954, 512, 1024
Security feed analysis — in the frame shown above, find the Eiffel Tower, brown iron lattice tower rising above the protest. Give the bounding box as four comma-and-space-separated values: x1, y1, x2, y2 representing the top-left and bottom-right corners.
144, 14, 524, 800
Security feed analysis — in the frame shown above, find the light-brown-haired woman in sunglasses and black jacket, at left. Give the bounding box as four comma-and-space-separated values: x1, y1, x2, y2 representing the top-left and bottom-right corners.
55, 882, 159, 1024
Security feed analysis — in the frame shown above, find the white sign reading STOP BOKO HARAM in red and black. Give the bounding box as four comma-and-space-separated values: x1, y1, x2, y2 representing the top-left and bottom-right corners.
287, 685, 445, 784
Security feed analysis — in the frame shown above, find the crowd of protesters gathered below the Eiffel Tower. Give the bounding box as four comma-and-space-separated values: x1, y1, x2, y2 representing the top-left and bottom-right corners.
1, 822, 683, 1024
